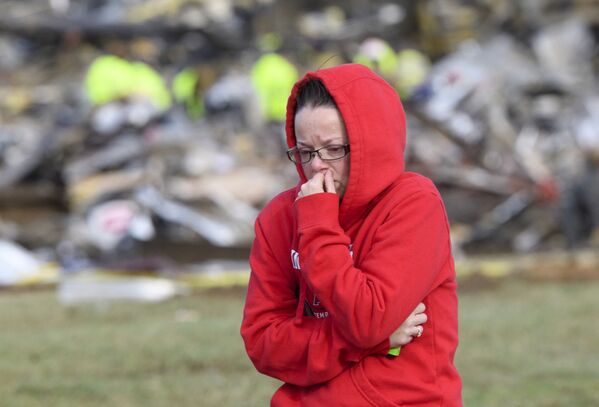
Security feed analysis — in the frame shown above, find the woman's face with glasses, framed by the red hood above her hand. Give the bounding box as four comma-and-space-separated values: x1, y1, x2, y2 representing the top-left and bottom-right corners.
295, 106, 349, 198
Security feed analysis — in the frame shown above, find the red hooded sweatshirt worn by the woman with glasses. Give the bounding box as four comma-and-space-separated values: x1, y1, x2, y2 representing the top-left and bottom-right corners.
241, 64, 462, 407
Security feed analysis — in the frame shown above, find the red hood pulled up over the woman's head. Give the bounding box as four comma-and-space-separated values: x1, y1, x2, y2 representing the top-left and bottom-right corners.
285, 64, 406, 228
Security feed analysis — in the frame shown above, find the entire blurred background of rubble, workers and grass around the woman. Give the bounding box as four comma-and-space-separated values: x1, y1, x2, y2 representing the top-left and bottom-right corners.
0, 0, 599, 406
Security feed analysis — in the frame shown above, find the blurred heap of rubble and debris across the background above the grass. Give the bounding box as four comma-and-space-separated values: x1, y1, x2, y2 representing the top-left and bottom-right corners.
0, 0, 599, 290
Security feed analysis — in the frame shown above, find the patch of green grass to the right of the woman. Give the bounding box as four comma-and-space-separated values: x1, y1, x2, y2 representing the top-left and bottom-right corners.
456, 281, 599, 407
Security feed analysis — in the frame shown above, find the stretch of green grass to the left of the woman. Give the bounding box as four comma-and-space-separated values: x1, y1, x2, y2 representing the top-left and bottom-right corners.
0, 291, 276, 407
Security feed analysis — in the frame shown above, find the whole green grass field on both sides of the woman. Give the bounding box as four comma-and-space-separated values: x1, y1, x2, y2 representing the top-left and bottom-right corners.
0, 280, 599, 407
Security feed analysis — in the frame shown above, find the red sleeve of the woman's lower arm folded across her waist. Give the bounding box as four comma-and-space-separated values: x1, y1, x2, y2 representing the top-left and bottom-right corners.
241, 215, 389, 386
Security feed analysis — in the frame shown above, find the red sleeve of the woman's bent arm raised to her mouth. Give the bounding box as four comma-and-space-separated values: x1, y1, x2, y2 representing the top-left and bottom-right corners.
295, 190, 451, 348
